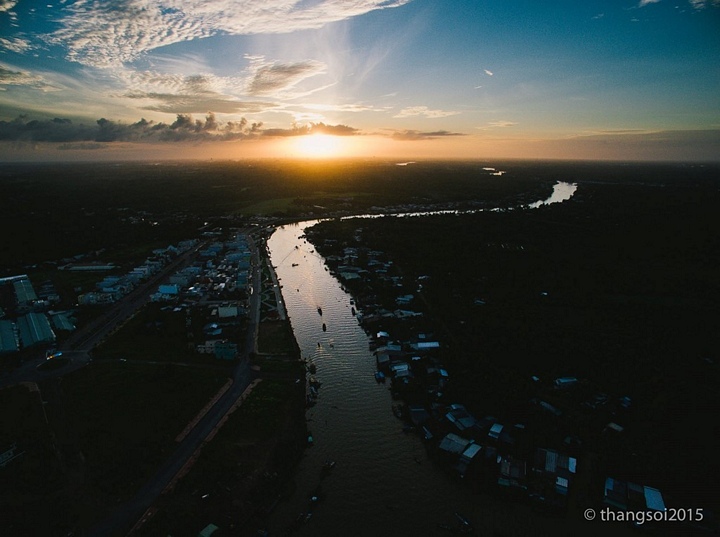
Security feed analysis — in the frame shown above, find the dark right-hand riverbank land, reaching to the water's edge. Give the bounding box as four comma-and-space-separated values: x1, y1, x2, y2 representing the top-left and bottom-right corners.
307, 177, 718, 529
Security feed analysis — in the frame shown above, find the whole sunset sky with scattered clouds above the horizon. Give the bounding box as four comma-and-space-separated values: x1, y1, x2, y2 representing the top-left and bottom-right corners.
0, 0, 720, 162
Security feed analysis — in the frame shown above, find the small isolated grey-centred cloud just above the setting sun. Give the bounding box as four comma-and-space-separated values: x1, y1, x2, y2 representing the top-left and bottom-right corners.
247, 56, 326, 95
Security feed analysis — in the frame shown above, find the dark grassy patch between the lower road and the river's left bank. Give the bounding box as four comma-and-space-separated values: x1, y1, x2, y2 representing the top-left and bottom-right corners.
140, 380, 306, 536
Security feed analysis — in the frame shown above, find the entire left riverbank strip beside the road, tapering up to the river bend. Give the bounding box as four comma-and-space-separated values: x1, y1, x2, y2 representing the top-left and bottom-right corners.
132, 231, 308, 536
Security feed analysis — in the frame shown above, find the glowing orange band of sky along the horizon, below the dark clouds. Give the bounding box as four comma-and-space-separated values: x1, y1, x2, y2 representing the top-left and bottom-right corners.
0, 131, 720, 162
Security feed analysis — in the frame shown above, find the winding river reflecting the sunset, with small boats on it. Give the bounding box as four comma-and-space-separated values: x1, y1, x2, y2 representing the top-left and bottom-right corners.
268, 183, 576, 536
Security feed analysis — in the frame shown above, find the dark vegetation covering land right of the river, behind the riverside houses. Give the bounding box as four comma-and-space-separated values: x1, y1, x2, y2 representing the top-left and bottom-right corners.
308, 164, 720, 508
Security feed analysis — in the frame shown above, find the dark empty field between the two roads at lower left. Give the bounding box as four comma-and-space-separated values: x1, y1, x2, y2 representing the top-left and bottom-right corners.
49, 362, 227, 527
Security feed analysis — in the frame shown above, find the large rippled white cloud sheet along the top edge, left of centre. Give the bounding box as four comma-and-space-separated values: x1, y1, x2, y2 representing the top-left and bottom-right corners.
46, 0, 411, 67
